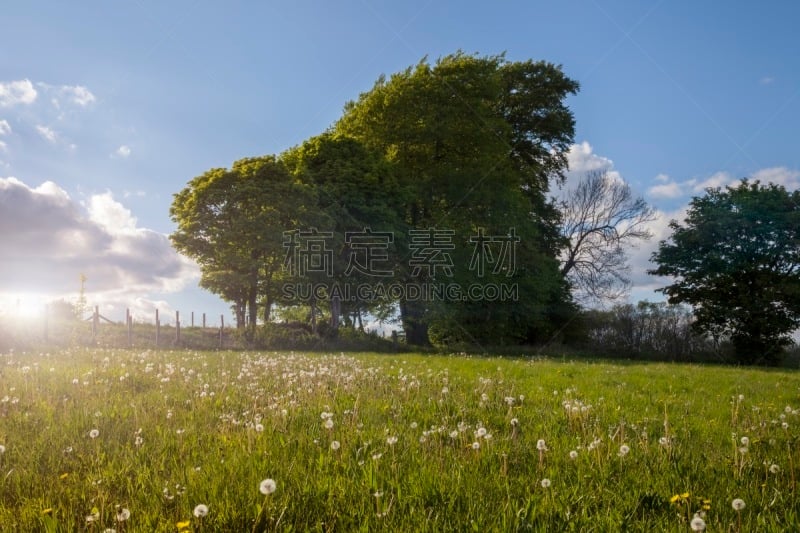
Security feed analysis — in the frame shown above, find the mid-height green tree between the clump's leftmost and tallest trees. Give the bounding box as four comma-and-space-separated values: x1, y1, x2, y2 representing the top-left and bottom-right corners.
281, 132, 408, 334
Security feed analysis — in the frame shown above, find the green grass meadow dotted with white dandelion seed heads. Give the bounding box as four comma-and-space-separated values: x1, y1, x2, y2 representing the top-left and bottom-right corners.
0, 349, 800, 532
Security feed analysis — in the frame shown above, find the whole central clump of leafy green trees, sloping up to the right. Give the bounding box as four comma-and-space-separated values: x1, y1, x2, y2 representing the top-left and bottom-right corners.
170, 52, 578, 344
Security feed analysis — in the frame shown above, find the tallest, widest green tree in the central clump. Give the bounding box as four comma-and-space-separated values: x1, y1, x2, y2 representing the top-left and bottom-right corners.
335, 52, 578, 344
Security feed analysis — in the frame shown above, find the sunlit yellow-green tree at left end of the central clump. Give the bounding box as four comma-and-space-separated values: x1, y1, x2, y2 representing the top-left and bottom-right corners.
170, 156, 318, 327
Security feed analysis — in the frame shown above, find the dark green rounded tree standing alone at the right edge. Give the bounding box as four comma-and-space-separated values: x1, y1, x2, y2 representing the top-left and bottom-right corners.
650, 180, 800, 364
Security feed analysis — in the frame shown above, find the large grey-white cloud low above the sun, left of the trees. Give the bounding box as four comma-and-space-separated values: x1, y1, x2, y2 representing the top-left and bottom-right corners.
0, 178, 199, 305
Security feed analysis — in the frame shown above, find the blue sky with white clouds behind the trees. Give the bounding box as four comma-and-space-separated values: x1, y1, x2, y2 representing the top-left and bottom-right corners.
0, 0, 800, 323
